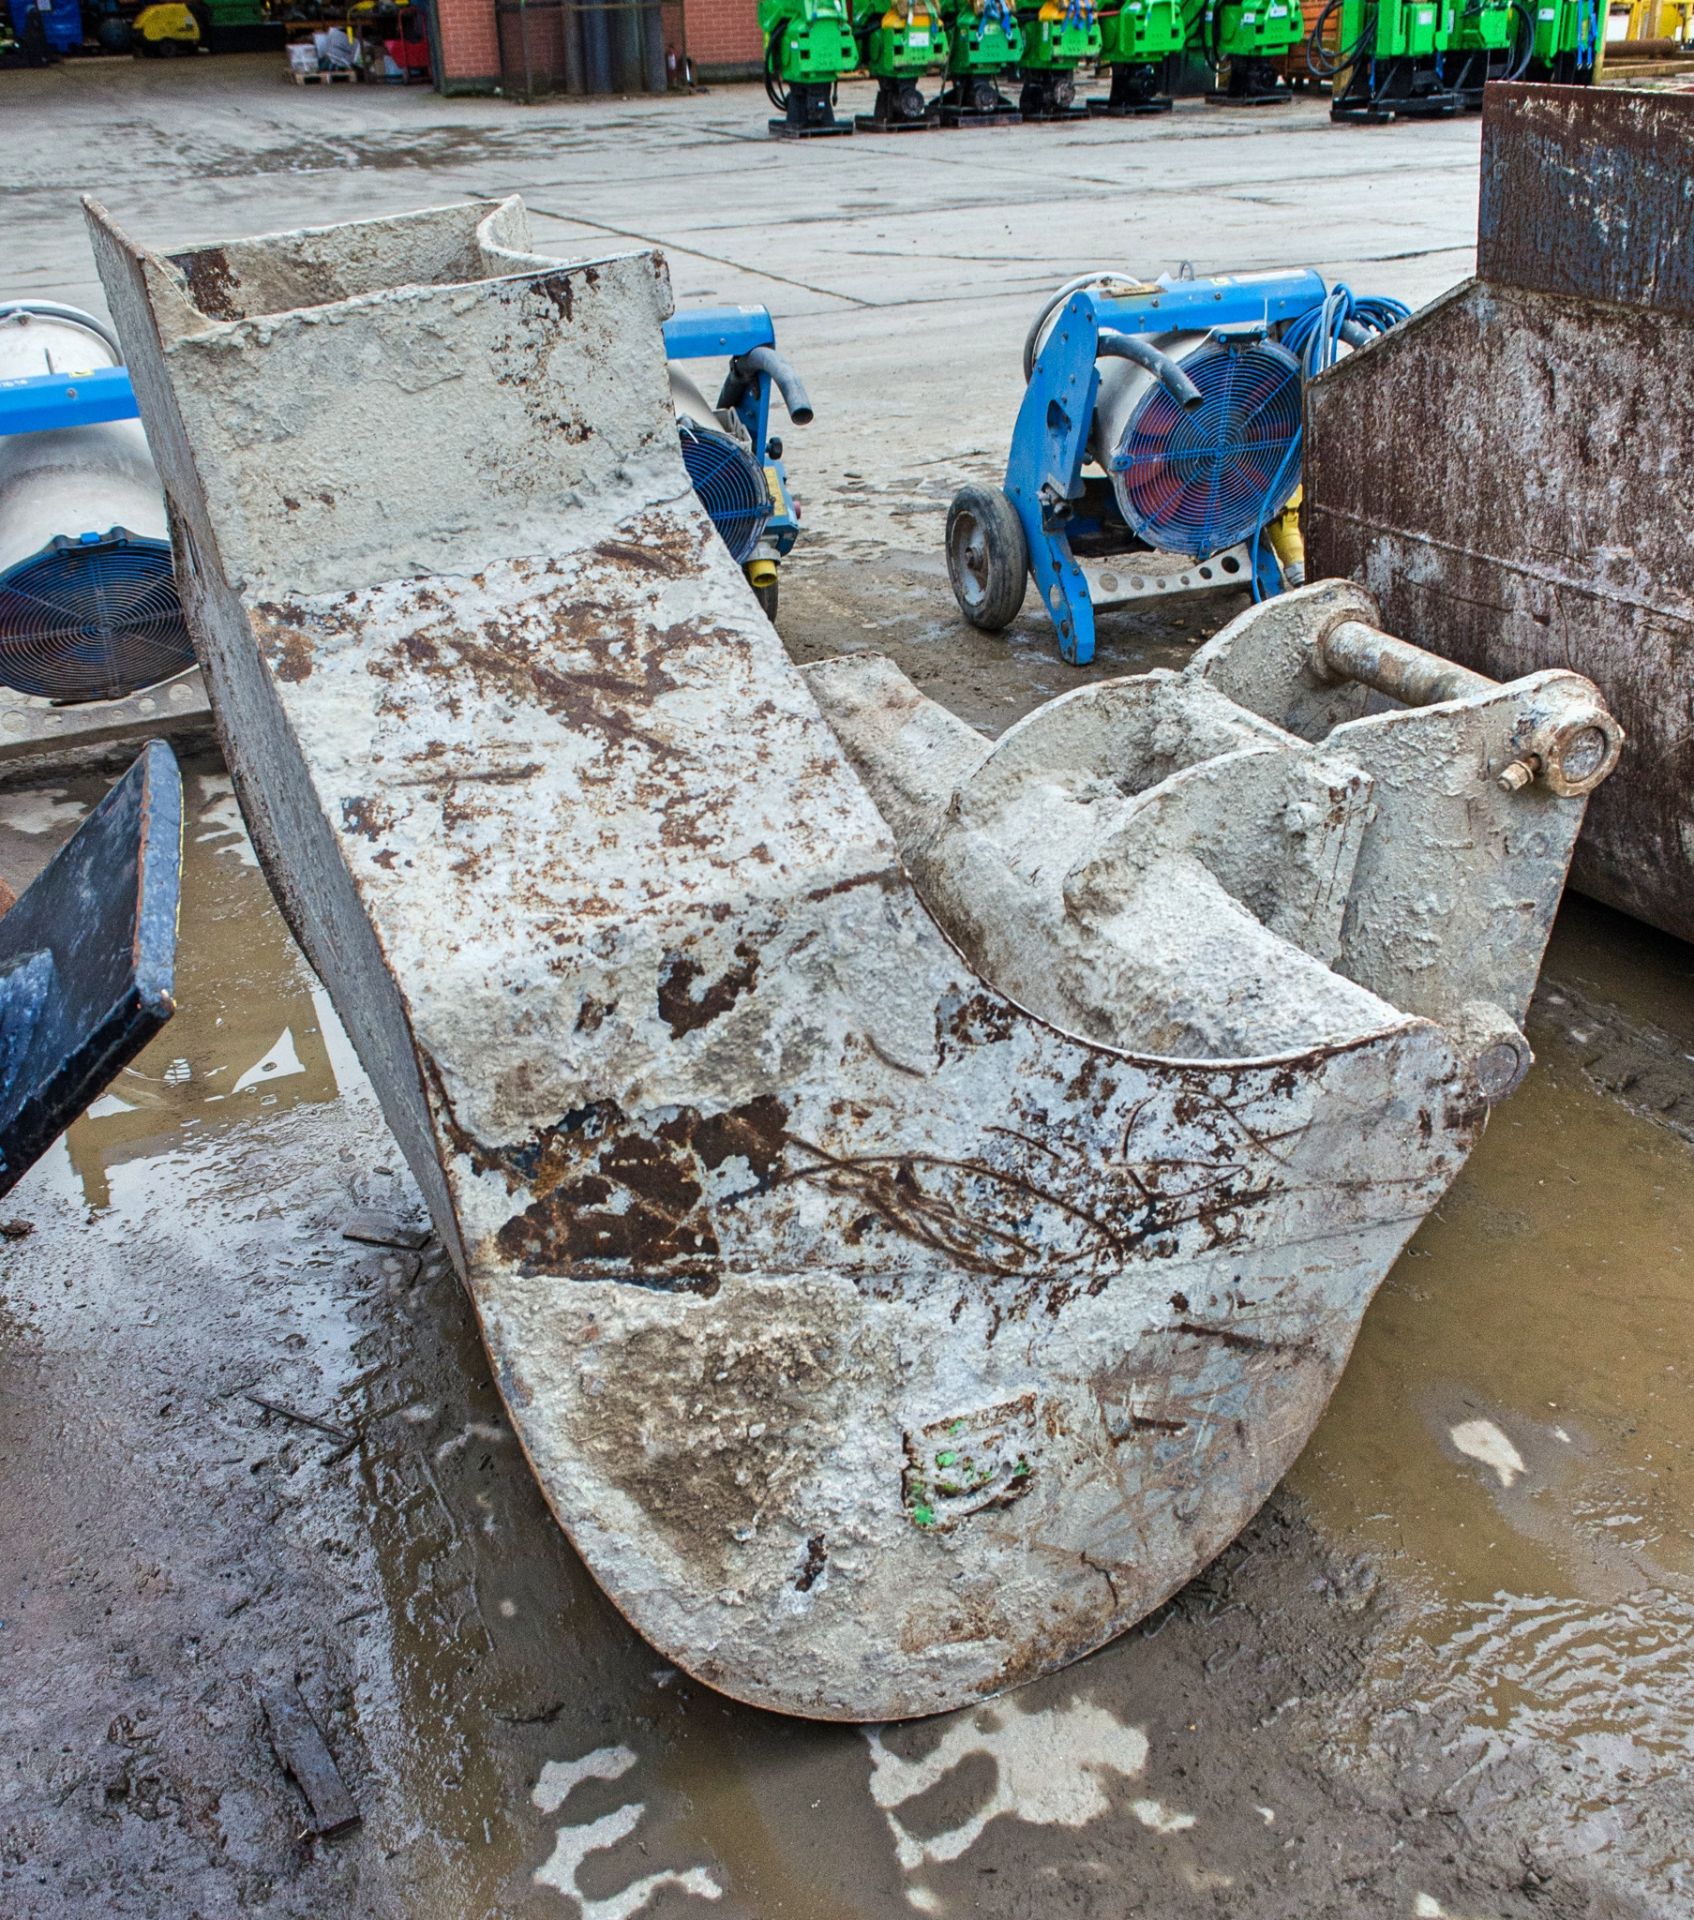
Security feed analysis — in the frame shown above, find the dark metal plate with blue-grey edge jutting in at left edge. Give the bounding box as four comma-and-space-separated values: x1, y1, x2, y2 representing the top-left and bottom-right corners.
0, 741, 182, 1194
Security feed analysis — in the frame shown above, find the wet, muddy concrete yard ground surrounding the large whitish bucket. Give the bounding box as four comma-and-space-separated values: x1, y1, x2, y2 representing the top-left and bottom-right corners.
0, 60, 1694, 1920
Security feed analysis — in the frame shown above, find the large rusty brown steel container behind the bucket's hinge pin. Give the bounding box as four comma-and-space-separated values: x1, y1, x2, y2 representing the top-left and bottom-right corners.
1306, 86, 1694, 939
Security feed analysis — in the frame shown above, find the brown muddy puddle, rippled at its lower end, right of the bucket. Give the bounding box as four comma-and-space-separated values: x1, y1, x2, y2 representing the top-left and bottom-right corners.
1291, 952, 1694, 1912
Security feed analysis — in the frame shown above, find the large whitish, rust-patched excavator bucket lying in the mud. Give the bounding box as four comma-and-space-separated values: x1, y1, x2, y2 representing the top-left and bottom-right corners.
90, 202, 1617, 1720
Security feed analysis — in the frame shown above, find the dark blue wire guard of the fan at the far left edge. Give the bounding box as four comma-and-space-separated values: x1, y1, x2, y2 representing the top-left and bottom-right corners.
0, 526, 194, 705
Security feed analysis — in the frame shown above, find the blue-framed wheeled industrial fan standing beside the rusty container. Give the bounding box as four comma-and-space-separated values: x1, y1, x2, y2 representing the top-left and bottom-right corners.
947, 269, 1408, 666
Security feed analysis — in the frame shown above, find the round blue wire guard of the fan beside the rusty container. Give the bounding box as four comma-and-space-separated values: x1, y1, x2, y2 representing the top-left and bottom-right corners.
1112, 340, 1300, 559
